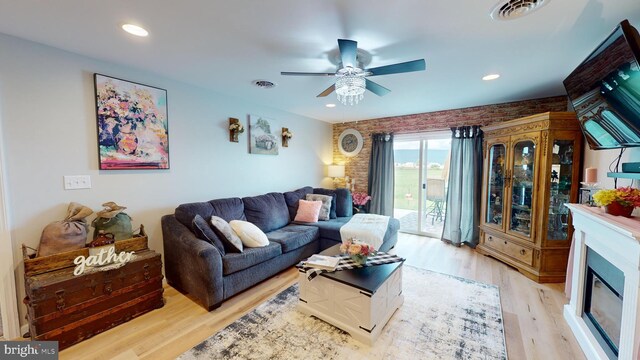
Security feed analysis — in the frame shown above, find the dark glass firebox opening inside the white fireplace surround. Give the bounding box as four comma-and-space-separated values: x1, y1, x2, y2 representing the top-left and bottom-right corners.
582, 248, 624, 359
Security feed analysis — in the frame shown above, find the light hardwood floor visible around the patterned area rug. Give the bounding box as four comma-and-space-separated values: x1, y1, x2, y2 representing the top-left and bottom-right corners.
60, 234, 584, 360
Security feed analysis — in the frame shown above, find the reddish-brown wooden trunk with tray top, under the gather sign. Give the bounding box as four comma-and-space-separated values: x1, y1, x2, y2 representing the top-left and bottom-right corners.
24, 229, 164, 350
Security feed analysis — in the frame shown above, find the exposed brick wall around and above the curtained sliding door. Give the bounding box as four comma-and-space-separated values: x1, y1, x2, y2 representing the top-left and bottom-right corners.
333, 96, 567, 192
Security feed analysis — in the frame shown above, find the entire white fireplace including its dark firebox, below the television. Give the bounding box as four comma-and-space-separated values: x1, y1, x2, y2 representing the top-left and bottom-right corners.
564, 204, 640, 360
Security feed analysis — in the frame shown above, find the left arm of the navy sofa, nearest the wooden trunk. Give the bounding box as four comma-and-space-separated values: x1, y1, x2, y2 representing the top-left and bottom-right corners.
162, 215, 224, 311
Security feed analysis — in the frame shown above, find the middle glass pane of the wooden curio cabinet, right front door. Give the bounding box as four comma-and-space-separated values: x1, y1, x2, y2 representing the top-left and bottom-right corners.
508, 140, 535, 237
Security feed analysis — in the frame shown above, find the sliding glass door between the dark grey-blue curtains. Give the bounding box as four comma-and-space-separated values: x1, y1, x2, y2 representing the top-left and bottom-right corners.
393, 131, 451, 238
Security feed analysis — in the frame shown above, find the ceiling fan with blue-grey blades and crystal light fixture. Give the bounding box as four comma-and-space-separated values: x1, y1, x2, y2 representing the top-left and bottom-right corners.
280, 39, 426, 105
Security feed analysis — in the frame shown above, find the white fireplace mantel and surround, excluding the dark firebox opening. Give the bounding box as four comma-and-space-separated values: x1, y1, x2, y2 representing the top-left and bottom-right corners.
564, 204, 640, 359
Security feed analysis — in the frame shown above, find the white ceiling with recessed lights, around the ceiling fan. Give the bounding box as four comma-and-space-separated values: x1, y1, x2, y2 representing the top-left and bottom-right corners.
0, 0, 640, 122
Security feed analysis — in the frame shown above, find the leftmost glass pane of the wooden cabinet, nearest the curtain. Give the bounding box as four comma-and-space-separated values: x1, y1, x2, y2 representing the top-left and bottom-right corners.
485, 144, 507, 228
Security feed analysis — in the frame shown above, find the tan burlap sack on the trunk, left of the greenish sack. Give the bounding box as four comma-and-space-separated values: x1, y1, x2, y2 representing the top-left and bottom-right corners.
37, 202, 93, 256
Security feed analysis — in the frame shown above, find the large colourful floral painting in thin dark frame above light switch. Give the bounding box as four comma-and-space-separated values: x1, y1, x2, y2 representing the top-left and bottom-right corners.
94, 74, 169, 170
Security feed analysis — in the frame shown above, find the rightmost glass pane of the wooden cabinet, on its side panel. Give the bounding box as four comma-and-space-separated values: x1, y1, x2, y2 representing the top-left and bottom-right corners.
547, 140, 575, 240
